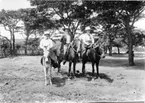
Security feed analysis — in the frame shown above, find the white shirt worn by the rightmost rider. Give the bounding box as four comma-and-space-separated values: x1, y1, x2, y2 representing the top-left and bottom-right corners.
79, 34, 94, 45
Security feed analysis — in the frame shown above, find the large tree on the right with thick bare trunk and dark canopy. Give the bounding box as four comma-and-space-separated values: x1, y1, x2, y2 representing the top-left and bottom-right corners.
88, 1, 145, 66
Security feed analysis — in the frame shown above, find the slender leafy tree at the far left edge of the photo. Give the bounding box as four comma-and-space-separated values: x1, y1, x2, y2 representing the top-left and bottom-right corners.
0, 10, 20, 55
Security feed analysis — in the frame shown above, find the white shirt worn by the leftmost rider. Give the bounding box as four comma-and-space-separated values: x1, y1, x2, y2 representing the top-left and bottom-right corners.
40, 39, 53, 50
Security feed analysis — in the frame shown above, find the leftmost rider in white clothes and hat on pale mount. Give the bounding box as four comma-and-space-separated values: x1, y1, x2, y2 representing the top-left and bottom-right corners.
40, 31, 54, 62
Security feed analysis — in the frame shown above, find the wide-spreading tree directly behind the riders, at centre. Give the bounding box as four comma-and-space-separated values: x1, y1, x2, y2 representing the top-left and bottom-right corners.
30, 0, 92, 40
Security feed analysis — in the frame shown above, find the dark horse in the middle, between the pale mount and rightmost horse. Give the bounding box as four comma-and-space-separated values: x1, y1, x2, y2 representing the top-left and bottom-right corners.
66, 39, 79, 76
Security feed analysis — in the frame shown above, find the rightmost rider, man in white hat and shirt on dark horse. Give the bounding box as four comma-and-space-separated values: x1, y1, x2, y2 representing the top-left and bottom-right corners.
77, 27, 95, 56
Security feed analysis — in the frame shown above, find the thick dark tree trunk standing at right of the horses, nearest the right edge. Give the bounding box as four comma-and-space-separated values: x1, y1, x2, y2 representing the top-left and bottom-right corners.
126, 20, 135, 66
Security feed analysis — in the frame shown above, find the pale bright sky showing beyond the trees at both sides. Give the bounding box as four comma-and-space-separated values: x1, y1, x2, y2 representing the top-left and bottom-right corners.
0, 0, 145, 39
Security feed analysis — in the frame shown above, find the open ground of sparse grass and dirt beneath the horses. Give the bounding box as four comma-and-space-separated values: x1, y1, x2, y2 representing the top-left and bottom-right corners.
0, 52, 145, 103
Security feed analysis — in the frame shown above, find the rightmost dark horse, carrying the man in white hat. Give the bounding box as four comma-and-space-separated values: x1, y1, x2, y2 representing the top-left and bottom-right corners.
81, 43, 105, 77
